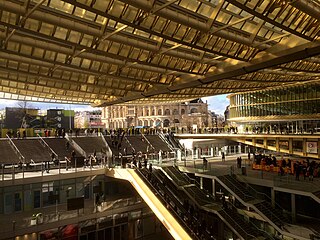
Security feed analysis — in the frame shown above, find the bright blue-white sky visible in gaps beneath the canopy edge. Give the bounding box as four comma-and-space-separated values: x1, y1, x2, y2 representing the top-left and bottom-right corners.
0, 95, 229, 115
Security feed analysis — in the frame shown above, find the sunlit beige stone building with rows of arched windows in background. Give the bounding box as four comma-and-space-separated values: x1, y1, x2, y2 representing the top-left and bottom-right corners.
102, 99, 212, 129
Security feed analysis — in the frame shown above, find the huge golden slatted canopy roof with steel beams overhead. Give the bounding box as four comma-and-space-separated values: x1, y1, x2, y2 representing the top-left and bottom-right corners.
0, 0, 320, 106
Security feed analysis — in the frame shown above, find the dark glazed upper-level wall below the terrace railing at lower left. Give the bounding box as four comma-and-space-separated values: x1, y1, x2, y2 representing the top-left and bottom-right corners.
0, 175, 134, 214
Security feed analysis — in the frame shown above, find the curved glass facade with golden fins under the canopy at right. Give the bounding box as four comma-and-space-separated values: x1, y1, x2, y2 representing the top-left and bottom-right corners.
229, 83, 320, 120
